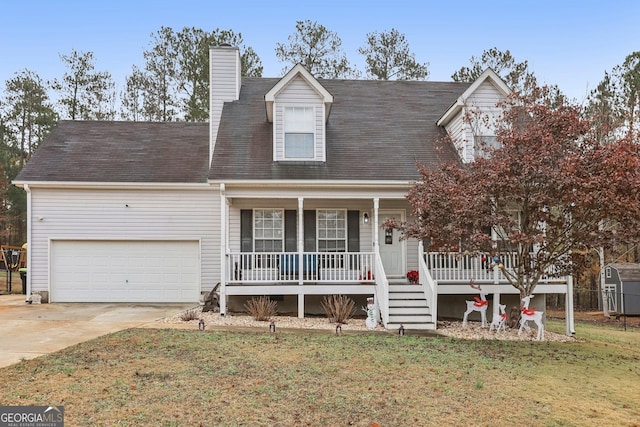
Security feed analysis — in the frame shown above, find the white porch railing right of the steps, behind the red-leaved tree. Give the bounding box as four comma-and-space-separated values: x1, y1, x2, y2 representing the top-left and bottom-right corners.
424, 252, 566, 283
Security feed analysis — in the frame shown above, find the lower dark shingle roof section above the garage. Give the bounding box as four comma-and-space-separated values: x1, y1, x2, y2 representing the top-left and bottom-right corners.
16, 121, 209, 183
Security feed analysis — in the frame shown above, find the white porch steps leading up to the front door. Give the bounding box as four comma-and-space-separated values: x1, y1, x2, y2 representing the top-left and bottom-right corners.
387, 282, 436, 330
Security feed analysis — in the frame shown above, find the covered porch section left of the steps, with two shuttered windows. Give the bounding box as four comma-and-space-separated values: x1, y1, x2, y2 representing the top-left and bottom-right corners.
220, 183, 417, 317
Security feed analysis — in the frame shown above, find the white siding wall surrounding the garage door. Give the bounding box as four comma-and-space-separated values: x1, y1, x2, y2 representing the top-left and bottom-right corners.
29, 187, 220, 291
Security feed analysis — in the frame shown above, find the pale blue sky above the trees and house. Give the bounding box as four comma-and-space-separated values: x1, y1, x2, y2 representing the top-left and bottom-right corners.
0, 0, 640, 102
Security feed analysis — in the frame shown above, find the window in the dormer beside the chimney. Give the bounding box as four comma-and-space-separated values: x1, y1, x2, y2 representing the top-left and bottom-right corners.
284, 107, 315, 159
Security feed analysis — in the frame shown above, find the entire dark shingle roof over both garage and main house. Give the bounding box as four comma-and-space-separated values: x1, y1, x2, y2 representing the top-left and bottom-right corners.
16, 78, 469, 183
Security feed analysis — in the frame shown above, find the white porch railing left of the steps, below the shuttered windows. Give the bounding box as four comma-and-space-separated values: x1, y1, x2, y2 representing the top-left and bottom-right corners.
226, 252, 376, 284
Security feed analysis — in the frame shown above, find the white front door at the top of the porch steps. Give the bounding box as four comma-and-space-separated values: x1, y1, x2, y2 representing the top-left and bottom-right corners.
378, 211, 406, 278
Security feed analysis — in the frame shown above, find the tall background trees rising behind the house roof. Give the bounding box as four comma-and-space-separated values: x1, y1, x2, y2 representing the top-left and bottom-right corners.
0, 20, 640, 247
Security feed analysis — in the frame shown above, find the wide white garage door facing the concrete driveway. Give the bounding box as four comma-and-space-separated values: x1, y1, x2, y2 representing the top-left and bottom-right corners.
50, 240, 200, 302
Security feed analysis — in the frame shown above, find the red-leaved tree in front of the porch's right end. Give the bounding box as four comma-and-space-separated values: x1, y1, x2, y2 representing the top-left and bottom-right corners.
388, 88, 640, 297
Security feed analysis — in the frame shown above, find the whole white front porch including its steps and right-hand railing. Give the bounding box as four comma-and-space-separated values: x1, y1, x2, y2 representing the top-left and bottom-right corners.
215, 186, 573, 334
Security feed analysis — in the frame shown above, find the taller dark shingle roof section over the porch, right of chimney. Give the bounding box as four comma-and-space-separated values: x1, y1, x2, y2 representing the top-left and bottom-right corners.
209, 78, 469, 181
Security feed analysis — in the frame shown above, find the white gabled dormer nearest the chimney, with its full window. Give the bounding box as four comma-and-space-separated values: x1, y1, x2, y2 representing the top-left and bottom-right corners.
264, 64, 333, 161
